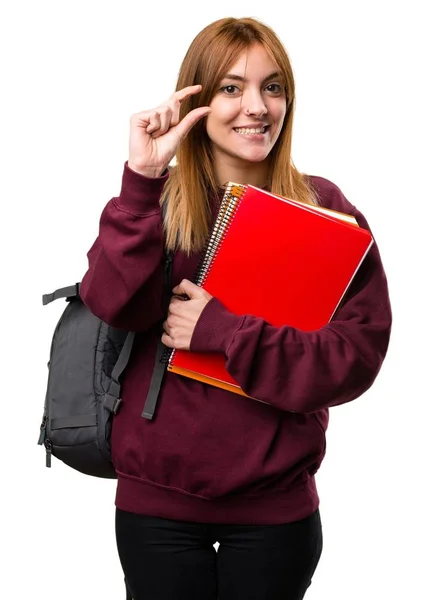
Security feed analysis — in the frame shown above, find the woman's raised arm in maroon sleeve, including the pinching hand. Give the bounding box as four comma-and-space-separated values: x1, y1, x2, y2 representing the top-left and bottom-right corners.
80, 85, 211, 331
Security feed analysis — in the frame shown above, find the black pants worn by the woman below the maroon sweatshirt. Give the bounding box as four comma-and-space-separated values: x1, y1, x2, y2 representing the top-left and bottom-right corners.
116, 510, 322, 600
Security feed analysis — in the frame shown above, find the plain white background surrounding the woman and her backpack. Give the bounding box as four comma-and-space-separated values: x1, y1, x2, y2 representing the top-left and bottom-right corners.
0, 0, 444, 600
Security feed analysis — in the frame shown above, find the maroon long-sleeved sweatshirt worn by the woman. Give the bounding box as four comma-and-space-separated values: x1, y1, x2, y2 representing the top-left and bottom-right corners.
81, 165, 391, 524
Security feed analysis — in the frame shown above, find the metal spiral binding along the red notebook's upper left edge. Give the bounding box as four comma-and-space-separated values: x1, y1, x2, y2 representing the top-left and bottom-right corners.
195, 182, 246, 286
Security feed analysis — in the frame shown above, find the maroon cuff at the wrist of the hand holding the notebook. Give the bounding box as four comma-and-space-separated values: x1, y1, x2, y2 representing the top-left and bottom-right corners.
190, 298, 244, 353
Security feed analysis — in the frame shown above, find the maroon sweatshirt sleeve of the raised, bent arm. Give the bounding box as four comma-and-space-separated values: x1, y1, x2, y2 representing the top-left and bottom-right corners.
80, 164, 168, 331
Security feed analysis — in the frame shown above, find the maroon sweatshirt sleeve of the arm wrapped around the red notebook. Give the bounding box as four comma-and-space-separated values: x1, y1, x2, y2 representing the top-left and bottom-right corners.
191, 197, 391, 413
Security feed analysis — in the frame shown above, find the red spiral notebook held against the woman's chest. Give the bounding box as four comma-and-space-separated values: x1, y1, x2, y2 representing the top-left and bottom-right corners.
168, 182, 373, 396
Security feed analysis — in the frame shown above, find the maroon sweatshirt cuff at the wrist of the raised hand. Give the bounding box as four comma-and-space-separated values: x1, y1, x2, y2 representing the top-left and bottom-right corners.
115, 162, 168, 217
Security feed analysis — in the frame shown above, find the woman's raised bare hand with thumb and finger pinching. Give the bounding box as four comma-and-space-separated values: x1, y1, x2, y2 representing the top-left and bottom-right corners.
128, 85, 211, 177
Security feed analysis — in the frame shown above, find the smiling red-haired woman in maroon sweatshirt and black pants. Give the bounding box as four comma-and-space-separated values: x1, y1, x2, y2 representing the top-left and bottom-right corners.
81, 18, 391, 600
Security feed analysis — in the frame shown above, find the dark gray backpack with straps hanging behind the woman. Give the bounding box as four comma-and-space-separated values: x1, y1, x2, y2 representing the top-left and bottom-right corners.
38, 253, 172, 478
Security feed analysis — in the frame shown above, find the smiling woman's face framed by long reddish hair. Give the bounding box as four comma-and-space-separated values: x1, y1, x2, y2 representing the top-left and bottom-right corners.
206, 44, 286, 177
